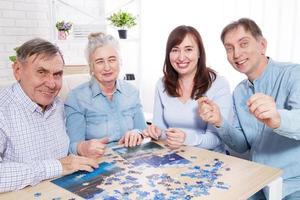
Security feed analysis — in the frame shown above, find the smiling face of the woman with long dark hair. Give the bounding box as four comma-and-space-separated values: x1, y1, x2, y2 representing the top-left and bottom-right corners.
169, 35, 199, 77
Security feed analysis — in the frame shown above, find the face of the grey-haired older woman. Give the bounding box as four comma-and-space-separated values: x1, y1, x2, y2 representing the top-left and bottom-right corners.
91, 44, 120, 84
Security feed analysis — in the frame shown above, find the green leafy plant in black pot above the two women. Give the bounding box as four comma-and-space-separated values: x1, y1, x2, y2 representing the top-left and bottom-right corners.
107, 10, 137, 39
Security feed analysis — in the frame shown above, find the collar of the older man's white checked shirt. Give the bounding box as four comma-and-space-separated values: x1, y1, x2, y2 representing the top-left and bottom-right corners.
13, 82, 57, 113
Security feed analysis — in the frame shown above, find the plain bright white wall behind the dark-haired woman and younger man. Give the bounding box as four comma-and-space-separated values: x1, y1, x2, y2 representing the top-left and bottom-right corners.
140, 0, 300, 112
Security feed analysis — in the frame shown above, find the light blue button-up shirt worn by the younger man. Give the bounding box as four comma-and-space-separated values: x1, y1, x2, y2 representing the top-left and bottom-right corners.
218, 59, 300, 196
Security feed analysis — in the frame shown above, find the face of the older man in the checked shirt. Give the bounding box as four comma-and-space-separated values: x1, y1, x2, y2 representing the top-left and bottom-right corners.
14, 54, 64, 109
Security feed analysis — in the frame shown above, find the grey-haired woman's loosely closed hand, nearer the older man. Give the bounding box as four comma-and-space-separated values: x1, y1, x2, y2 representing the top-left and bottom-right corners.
77, 137, 108, 158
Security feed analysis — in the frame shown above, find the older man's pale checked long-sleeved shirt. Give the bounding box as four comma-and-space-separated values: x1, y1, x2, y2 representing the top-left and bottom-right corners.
0, 83, 69, 192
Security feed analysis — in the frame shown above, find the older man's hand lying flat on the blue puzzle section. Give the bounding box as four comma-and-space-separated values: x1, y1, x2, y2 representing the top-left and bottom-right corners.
59, 155, 98, 175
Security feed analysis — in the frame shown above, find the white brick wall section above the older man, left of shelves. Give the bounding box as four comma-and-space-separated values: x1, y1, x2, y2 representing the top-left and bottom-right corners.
0, 0, 51, 80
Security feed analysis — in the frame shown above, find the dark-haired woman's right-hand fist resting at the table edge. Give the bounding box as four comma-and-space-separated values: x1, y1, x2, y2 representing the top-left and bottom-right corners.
166, 128, 186, 149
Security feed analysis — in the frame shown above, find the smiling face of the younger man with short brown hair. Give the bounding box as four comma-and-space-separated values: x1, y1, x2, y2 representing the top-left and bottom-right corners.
224, 26, 267, 80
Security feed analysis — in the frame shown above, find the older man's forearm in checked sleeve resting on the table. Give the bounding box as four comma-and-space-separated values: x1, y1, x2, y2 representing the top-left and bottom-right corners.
0, 160, 62, 192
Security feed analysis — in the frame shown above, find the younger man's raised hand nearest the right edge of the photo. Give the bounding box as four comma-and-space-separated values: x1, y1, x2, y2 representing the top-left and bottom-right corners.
247, 93, 281, 129
